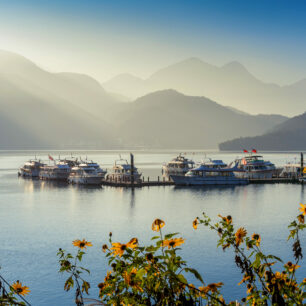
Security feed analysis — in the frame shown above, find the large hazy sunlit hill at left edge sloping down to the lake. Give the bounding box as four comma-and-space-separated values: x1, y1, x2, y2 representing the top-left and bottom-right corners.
0, 51, 118, 149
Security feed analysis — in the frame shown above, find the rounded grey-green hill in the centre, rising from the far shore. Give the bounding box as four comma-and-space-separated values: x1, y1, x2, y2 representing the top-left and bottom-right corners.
109, 90, 287, 149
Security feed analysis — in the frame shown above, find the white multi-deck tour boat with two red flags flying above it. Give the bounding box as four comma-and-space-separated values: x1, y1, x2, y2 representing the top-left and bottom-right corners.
230, 154, 276, 179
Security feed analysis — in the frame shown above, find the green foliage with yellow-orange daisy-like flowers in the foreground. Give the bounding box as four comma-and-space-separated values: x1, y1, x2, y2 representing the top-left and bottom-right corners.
58, 204, 306, 306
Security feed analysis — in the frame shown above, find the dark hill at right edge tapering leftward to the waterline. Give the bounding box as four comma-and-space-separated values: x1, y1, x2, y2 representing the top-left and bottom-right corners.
219, 112, 306, 151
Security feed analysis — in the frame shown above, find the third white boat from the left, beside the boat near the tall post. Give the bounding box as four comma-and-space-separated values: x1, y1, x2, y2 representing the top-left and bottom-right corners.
68, 163, 106, 185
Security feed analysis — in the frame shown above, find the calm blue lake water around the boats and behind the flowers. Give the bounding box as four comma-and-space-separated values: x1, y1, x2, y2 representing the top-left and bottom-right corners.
0, 151, 306, 305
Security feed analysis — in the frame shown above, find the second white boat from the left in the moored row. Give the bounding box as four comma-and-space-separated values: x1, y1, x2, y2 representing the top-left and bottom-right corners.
39, 161, 71, 181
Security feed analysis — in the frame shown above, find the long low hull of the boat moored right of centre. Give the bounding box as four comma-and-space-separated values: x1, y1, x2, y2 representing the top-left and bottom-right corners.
170, 175, 248, 186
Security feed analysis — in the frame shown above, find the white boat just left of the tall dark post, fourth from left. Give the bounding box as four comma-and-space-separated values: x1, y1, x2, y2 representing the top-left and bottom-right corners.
106, 159, 141, 183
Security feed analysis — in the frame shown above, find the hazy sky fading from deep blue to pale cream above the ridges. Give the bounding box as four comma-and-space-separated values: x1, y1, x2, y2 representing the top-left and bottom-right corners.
0, 0, 306, 84
